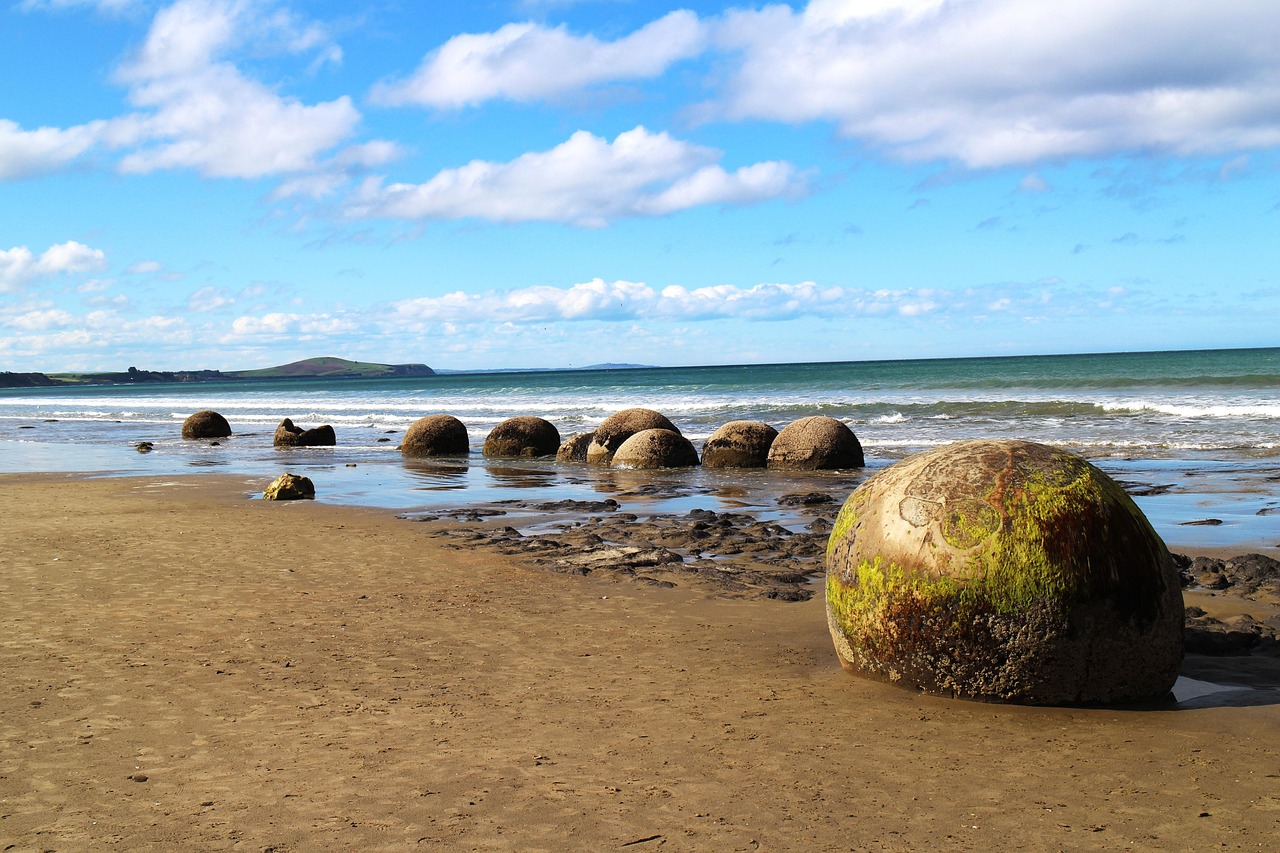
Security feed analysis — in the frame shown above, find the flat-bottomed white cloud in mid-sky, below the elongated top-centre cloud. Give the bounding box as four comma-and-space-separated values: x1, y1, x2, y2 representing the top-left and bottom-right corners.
348, 127, 805, 227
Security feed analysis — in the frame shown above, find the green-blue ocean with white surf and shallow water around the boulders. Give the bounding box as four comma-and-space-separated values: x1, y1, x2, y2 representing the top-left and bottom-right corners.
0, 348, 1280, 544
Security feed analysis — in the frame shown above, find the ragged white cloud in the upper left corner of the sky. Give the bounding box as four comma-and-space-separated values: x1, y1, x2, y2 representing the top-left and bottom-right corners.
0, 0, 373, 179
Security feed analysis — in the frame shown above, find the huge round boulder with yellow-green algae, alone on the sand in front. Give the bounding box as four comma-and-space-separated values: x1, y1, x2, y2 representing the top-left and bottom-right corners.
827, 441, 1183, 704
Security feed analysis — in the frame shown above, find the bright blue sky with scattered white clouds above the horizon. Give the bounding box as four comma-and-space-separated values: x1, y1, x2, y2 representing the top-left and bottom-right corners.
0, 0, 1280, 373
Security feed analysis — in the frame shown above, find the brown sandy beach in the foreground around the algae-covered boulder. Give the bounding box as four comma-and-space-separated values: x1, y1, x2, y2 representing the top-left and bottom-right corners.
0, 475, 1280, 852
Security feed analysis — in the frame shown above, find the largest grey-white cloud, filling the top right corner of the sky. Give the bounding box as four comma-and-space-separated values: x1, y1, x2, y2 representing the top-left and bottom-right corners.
710, 0, 1280, 168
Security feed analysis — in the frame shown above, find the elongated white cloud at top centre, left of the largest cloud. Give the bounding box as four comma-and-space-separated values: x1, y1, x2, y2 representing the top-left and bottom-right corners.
372, 10, 707, 108
